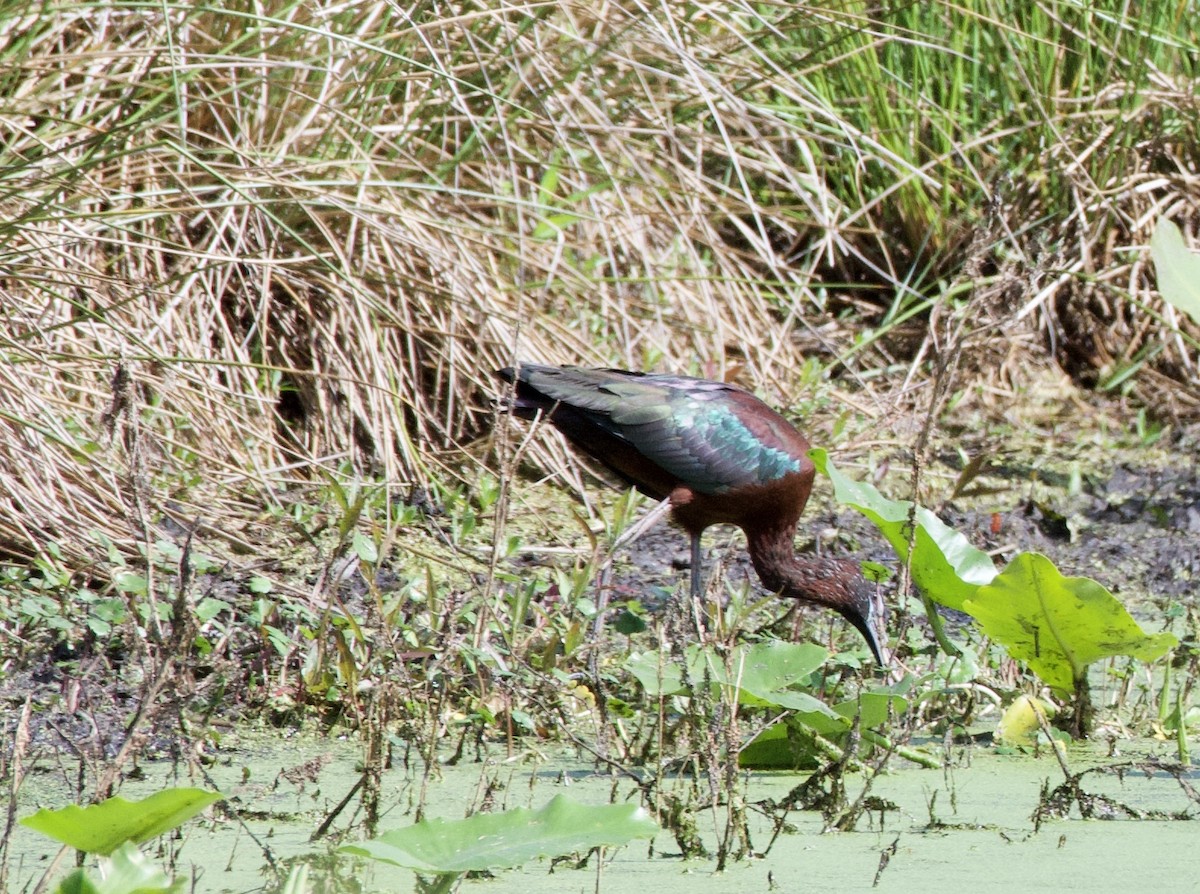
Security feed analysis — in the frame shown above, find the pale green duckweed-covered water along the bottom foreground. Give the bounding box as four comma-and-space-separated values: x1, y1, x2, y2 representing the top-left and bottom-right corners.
10, 736, 1200, 894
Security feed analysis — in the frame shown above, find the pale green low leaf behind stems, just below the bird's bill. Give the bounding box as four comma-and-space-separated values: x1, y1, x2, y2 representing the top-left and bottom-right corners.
625, 641, 832, 716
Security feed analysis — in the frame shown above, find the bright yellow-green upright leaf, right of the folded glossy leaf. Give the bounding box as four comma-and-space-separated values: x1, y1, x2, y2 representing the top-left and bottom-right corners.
962, 552, 1178, 692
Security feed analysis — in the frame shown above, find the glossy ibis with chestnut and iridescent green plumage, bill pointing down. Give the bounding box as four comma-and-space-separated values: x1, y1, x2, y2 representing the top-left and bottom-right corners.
497, 364, 883, 664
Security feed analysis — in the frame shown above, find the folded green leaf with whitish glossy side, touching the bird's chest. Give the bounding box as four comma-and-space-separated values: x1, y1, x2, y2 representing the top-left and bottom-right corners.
809, 449, 996, 610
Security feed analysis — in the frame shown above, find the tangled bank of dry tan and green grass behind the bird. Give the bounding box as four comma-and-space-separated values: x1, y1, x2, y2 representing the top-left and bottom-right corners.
0, 2, 1198, 565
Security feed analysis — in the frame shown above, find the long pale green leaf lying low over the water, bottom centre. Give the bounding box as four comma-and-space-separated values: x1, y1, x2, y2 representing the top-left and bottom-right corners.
338, 794, 659, 874
